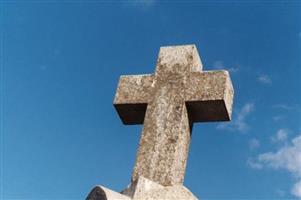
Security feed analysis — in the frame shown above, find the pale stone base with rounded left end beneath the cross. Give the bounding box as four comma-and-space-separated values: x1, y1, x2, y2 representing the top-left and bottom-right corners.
86, 177, 198, 200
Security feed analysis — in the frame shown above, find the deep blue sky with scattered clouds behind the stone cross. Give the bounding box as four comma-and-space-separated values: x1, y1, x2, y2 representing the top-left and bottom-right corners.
0, 0, 301, 200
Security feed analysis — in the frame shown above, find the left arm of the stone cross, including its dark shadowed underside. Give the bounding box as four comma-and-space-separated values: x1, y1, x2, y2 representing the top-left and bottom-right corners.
114, 74, 153, 124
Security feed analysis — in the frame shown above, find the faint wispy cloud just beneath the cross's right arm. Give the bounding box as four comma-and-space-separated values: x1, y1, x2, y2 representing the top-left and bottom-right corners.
217, 103, 255, 132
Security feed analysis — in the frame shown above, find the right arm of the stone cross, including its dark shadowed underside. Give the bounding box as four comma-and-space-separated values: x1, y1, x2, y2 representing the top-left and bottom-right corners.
185, 71, 234, 122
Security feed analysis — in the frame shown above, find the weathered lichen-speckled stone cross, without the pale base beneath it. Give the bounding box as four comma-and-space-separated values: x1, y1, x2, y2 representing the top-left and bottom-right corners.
114, 45, 233, 186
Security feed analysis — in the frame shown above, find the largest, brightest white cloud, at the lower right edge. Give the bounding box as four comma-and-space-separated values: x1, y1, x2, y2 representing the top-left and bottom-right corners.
247, 134, 301, 199
